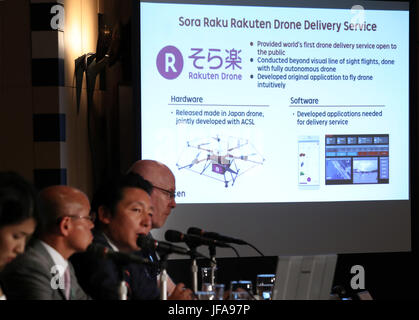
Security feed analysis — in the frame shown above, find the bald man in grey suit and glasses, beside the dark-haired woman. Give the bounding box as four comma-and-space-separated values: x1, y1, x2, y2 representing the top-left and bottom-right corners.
2, 186, 94, 300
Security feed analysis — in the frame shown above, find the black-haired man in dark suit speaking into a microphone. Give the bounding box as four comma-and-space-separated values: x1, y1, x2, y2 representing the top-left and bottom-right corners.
72, 174, 191, 300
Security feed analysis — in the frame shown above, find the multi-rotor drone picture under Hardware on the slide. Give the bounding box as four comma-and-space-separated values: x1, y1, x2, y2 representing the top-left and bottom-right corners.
176, 135, 265, 188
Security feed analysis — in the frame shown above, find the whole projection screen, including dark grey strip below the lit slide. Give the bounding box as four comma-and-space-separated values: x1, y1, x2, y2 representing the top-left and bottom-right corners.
139, 0, 413, 256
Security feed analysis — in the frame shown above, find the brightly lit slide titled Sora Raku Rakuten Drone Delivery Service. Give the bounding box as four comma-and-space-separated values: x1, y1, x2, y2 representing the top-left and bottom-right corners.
140, 1, 409, 204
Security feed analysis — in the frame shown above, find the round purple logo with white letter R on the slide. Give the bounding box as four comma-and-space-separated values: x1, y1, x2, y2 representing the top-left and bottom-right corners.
157, 46, 183, 80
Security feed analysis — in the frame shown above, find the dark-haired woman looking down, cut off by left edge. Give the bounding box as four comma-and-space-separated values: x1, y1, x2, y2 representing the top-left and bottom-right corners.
0, 172, 37, 300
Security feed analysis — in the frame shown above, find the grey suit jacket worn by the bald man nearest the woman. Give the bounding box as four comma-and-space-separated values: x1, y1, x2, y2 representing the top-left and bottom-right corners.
1, 240, 89, 300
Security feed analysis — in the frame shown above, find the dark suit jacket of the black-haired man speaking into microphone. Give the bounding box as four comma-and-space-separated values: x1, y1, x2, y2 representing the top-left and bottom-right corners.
71, 231, 160, 300
